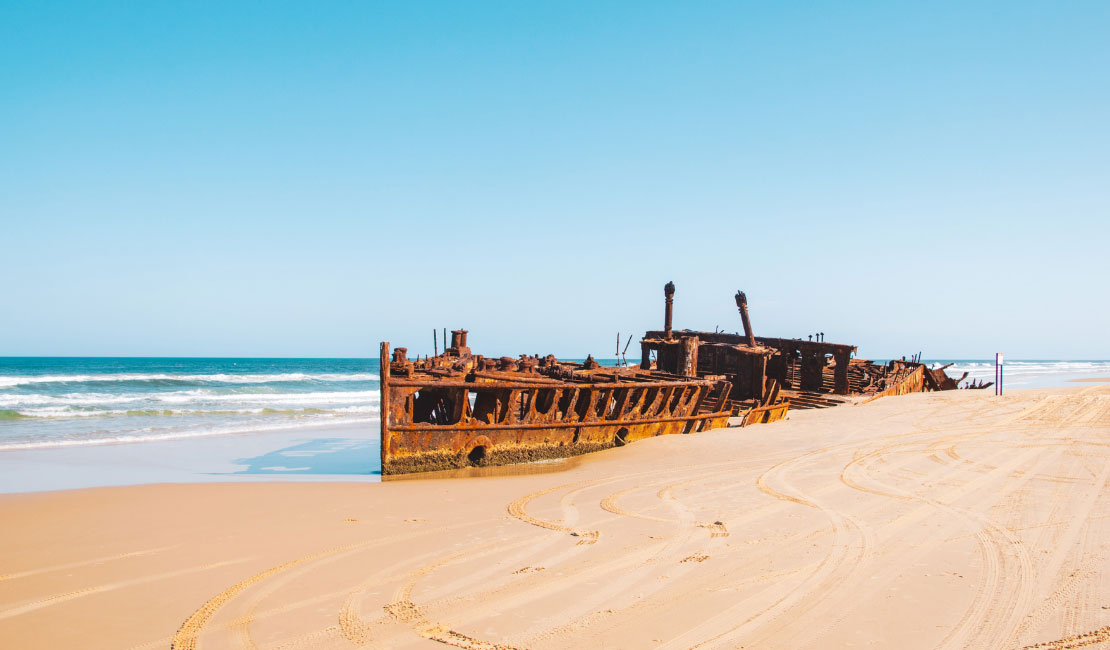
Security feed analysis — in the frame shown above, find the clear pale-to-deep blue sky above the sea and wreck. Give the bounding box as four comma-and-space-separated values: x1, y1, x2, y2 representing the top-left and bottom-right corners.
0, 0, 1110, 358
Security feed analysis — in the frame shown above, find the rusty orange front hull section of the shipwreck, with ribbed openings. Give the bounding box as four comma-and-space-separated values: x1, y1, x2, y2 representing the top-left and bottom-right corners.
381, 331, 730, 475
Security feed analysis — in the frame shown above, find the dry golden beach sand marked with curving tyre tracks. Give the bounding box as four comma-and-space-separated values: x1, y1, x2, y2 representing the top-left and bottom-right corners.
0, 386, 1110, 650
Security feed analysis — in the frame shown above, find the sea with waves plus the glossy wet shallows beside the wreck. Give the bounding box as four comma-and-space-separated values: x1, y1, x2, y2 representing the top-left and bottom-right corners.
0, 357, 1110, 492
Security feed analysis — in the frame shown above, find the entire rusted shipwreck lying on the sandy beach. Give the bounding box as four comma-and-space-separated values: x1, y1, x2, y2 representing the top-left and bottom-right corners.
381, 283, 958, 475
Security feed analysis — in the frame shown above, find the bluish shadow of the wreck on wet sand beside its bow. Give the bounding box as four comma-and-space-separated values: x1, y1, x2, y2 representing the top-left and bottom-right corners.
231, 438, 382, 476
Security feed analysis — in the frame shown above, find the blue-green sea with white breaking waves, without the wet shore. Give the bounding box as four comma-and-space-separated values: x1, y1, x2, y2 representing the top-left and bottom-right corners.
0, 357, 1110, 451
